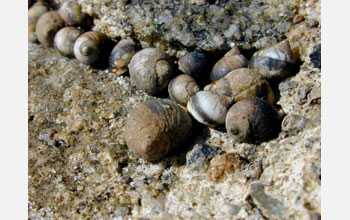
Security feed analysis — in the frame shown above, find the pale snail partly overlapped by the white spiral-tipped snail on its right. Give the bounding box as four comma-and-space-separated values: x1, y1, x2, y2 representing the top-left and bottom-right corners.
54, 27, 82, 56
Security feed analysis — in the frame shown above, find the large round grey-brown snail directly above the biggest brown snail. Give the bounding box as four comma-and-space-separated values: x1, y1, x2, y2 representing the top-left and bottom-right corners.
128, 48, 173, 95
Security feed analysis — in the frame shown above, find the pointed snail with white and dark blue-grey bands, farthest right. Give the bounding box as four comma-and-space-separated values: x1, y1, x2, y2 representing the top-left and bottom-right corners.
249, 40, 295, 79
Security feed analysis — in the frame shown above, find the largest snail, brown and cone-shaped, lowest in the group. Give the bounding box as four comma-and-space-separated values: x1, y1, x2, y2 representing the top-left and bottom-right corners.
124, 99, 192, 160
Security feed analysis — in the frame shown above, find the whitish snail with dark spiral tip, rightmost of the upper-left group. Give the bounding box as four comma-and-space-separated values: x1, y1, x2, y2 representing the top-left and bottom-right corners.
74, 31, 107, 64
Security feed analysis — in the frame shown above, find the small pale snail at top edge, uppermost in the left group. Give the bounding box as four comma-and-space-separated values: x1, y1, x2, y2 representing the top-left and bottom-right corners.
58, 1, 86, 25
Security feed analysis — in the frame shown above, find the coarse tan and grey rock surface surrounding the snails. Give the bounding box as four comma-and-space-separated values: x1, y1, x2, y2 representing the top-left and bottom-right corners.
28, 0, 321, 220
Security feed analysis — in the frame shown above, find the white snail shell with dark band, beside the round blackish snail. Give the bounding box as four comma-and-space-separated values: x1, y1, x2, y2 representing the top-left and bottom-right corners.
187, 91, 230, 127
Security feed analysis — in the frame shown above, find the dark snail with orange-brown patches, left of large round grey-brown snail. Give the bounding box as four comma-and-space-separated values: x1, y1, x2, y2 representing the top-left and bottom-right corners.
109, 39, 136, 76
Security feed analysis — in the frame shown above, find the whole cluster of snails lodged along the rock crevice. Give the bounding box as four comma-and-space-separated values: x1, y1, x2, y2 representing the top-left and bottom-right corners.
28, 1, 295, 160
